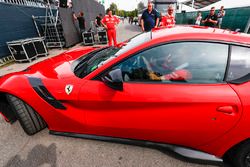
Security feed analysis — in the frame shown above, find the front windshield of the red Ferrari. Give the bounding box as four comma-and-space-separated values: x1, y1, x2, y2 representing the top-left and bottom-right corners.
73, 32, 151, 78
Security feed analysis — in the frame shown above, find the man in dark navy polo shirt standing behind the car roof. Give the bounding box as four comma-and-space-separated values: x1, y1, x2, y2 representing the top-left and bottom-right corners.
141, 2, 160, 32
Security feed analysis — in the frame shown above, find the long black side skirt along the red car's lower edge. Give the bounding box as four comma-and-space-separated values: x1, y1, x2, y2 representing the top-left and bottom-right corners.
49, 131, 223, 165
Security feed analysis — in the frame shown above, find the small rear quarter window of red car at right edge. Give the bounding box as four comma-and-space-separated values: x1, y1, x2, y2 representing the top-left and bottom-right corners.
227, 46, 250, 81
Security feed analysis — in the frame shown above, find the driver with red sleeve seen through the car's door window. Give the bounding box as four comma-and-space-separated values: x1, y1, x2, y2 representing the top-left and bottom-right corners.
148, 53, 192, 81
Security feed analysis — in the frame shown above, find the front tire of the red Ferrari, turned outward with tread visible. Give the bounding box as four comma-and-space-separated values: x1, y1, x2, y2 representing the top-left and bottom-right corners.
7, 95, 46, 135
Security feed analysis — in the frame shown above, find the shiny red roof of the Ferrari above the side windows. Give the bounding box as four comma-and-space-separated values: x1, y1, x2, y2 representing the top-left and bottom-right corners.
152, 25, 250, 45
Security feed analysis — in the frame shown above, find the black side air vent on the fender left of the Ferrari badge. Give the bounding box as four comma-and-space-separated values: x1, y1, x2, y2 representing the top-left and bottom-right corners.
28, 77, 66, 110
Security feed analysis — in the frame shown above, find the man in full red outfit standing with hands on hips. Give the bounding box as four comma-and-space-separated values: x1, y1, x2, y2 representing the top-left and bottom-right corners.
101, 9, 119, 46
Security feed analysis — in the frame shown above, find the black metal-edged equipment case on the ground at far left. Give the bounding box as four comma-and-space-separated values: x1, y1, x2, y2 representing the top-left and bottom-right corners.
7, 38, 48, 62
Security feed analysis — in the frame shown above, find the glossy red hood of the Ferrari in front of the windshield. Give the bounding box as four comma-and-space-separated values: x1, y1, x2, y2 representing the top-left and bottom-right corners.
24, 47, 97, 79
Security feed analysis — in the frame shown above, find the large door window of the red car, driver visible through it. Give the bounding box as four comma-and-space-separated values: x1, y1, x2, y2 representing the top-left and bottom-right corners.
113, 42, 228, 83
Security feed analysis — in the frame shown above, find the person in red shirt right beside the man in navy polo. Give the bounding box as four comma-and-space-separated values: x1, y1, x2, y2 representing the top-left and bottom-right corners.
161, 6, 175, 27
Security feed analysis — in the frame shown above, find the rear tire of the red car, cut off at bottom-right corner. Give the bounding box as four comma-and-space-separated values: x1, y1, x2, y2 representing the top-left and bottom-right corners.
230, 141, 250, 167
